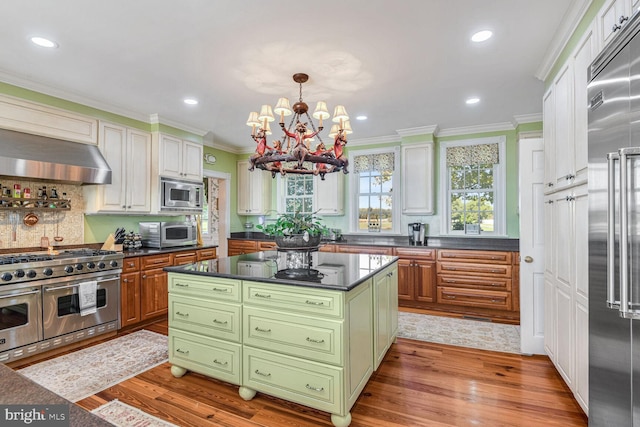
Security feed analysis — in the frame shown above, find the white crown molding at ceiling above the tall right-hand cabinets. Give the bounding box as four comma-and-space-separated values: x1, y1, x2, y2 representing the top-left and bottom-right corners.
535, 0, 593, 81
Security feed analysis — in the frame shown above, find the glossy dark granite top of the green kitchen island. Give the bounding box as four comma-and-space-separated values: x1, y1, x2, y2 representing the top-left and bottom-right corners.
164, 251, 398, 291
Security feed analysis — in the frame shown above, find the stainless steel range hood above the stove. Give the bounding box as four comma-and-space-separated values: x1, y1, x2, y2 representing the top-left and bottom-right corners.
0, 129, 111, 184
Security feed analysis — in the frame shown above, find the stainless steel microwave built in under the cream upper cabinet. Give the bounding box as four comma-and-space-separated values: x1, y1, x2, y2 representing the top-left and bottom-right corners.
160, 178, 204, 213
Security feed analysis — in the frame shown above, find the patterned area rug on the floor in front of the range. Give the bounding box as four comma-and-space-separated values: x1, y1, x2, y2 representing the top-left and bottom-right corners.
18, 330, 169, 402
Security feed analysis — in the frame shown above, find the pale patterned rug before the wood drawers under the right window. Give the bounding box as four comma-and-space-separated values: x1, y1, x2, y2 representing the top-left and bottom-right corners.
398, 311, 520, 354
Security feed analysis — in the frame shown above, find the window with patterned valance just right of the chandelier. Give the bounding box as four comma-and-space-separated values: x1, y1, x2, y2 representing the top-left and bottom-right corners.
349, 148, 400, 233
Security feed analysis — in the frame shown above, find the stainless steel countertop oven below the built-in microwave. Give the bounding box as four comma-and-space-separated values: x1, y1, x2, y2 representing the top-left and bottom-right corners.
138, 221, 198, 248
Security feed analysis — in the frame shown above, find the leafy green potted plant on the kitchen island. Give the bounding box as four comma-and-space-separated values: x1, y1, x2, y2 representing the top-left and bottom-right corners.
256, 212, 328, 248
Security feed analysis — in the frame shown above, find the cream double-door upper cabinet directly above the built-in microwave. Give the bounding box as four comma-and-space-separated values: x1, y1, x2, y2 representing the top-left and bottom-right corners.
159, 135, 203, 181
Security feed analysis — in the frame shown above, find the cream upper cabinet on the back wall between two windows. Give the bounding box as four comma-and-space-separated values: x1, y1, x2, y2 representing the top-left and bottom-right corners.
402, 143, 434, 215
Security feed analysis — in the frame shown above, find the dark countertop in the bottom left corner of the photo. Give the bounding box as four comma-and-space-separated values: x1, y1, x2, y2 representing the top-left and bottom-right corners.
0, 363, 113, 427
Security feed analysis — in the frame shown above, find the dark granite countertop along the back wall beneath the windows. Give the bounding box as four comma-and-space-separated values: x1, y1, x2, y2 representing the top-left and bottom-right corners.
231, 231, 520, 252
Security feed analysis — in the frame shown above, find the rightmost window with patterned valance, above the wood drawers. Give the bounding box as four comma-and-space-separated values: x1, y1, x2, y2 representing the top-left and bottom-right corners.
440, 137, 506, 235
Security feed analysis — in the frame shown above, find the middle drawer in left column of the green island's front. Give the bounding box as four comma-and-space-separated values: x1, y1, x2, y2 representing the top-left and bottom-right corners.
169, 294, 242, 342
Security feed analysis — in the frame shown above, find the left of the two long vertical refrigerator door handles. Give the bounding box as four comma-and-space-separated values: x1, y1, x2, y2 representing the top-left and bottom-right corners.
607, 152, 620, 310
